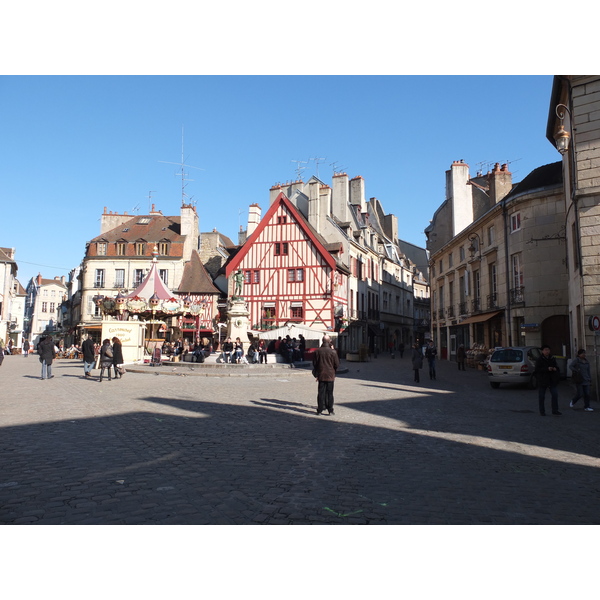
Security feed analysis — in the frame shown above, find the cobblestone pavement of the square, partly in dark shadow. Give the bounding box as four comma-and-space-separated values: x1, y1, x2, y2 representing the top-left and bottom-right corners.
0, 354, 600, 524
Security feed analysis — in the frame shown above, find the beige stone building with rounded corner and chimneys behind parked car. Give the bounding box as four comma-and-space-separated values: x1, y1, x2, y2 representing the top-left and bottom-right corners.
425, 161, 570, 360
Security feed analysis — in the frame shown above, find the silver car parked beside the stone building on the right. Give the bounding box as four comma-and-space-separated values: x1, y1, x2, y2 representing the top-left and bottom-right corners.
488, 346, 542, 389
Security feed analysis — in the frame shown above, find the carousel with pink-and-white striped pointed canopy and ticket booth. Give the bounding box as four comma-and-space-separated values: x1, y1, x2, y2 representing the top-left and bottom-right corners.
95, 247, 210, 364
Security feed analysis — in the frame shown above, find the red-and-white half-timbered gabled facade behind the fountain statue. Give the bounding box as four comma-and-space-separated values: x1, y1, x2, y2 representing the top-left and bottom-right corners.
225, 193, 347, 330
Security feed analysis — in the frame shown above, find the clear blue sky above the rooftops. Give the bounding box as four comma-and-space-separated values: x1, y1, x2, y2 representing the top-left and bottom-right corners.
0, 75, 560, 284
